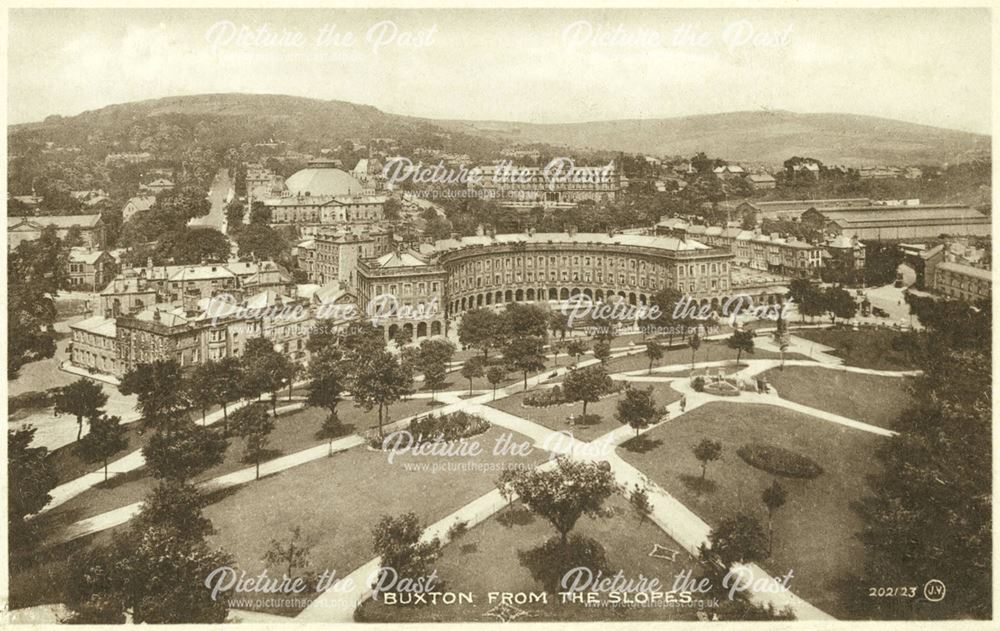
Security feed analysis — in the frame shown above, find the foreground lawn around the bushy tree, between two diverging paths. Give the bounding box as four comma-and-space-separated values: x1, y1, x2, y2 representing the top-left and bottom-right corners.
355, 495, 699, 623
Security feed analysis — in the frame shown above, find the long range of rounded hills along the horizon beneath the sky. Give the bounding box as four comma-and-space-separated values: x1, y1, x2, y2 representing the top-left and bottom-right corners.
9, 94, 990, 166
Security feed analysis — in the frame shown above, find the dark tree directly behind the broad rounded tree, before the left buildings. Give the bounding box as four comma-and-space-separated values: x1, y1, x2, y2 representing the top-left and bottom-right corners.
118, 359, 191, 432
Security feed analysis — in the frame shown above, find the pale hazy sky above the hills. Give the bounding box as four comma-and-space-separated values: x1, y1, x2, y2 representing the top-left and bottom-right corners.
8, 8, 991, 134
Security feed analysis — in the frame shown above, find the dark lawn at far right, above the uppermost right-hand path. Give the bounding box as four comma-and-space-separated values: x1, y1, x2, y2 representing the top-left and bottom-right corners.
789, 328, 920, 370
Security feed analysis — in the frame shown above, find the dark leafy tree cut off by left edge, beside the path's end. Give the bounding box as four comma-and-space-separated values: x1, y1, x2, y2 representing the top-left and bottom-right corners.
7, 425, 58, 547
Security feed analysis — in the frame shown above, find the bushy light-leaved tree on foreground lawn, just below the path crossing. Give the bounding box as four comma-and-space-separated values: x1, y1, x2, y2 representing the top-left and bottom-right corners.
511, 456, 618, 546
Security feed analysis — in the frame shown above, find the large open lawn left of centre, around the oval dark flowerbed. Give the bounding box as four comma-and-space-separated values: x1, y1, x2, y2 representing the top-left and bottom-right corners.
205, 427, 546, 615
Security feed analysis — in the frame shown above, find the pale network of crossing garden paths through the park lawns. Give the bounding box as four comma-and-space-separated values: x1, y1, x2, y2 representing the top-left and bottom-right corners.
37, 336, 919, 623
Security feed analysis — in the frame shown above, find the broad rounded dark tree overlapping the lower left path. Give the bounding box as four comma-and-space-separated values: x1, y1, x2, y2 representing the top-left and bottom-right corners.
142, 420, 228, 481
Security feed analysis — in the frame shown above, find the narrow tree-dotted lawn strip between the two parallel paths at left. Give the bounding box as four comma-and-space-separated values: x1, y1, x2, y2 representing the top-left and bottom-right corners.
37, 399, 441, 530
